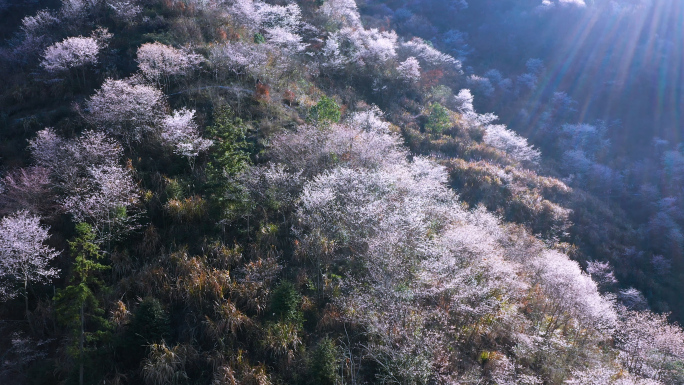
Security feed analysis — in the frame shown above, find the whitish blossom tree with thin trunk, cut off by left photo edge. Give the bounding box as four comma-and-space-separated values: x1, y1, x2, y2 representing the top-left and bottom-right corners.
0, 211, 59, 315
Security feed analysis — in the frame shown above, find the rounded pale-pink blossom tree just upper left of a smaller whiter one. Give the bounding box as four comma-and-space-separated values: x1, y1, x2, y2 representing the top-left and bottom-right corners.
85, 79, 166, 144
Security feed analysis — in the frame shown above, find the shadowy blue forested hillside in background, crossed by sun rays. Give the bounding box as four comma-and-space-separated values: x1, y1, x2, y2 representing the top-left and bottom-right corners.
364, 0, 684, 321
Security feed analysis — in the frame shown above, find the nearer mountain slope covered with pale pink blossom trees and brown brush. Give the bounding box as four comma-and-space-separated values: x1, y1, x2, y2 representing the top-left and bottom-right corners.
0, 0, 684, 384
